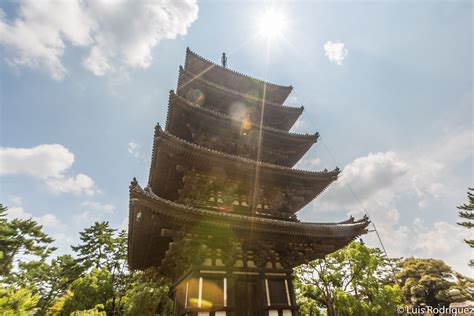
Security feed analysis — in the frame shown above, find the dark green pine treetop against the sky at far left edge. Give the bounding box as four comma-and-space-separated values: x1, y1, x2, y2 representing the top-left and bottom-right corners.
0, 204, 56, 277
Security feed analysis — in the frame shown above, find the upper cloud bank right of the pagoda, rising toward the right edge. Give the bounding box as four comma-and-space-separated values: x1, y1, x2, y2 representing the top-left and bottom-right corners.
315, 129, 474, 213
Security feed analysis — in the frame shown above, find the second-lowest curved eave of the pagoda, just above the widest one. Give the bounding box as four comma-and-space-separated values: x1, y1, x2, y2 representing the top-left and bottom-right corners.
148, 125, 340, 215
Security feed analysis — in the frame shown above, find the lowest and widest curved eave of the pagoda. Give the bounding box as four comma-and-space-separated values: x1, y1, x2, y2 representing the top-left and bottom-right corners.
128, 182, 369, 269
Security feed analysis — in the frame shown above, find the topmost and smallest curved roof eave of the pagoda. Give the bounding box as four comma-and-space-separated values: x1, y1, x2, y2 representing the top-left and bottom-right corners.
184, 47, 293, 104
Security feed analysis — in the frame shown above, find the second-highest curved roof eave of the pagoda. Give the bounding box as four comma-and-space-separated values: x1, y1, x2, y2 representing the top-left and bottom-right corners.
177, 66, 304, 131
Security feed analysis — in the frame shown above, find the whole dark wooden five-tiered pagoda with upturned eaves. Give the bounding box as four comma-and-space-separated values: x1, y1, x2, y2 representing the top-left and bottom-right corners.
128, 48, 369, 316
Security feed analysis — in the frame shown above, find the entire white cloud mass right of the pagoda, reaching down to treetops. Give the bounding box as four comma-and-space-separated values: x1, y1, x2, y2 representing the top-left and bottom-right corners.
314, 129, 472, 273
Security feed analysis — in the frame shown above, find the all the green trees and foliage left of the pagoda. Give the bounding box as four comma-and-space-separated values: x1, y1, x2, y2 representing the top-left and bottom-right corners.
0, 204, 172, 315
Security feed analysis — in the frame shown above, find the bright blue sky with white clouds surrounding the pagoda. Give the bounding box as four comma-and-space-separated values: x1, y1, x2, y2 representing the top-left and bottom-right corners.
0, 1, 473, 275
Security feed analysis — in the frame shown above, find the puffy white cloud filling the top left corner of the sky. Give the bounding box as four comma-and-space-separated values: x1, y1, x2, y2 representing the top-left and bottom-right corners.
0, 1, 92, 80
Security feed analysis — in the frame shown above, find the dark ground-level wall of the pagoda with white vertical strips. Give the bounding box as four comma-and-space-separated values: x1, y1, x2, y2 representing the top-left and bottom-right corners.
174, 270, 298, 316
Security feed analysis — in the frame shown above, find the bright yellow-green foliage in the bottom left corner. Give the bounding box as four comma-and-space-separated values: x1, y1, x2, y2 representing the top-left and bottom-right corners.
0, 286, 40, 316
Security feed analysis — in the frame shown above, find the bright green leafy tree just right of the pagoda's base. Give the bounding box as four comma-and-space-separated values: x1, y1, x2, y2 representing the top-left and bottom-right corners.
295, 242, 401, 316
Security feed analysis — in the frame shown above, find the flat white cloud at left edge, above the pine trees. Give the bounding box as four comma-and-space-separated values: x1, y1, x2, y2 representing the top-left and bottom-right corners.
0, 144, 99, 195
